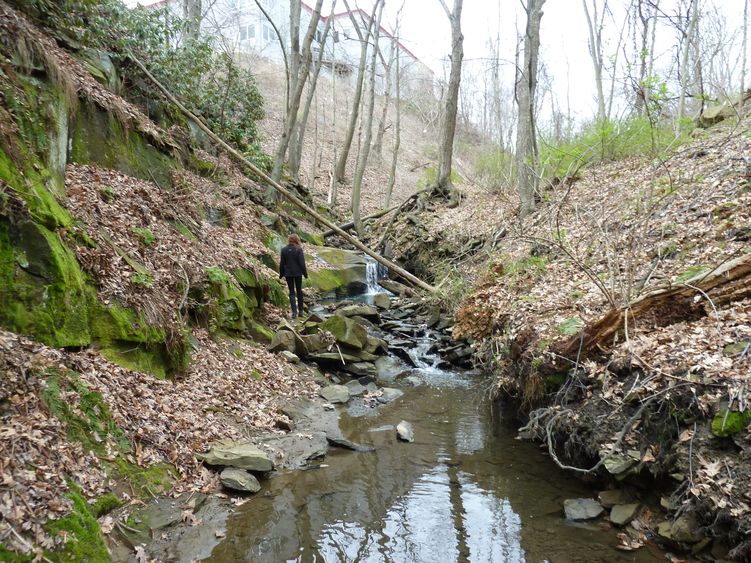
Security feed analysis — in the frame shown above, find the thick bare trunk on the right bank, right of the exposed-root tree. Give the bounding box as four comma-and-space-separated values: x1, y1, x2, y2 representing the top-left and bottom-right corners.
516, 0, 545, 217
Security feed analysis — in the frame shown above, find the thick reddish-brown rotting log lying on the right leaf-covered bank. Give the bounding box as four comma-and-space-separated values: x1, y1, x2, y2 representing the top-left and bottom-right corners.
553, 254, 751, 358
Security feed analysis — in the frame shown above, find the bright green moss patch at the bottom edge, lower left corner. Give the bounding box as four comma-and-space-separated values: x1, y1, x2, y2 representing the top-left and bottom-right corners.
47, 483, 110, 562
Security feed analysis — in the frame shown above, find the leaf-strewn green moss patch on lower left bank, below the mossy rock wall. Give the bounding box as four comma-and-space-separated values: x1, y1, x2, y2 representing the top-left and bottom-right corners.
42, 370, 131, 454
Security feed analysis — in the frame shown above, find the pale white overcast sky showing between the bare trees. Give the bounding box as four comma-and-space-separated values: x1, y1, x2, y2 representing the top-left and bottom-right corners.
126, 0, 751, 125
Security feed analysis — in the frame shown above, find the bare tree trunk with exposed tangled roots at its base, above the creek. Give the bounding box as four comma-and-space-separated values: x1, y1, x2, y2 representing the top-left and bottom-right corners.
435, 0, 464, 196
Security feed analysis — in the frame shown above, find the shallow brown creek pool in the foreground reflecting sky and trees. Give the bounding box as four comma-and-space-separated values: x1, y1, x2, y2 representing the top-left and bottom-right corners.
206, 328, 662, 562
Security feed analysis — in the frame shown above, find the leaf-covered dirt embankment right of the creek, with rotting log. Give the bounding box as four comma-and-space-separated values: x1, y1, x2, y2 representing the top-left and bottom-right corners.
378, 121, 751, 560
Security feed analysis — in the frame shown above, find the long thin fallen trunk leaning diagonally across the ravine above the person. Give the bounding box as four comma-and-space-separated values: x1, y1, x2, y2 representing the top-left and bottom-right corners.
130, 54, 436, 293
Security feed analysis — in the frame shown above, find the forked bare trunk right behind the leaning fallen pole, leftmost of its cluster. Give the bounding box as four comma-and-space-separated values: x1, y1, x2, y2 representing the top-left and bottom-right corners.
267, 0, 323, 191
